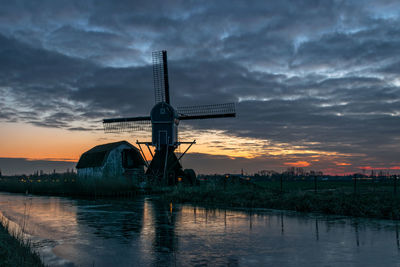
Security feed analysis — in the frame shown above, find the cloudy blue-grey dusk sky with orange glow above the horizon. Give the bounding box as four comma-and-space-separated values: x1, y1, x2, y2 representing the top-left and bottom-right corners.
0, 0, 400, 174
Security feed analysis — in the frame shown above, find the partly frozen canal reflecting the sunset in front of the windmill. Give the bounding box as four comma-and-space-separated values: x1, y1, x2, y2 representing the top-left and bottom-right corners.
0, 193, 400, 267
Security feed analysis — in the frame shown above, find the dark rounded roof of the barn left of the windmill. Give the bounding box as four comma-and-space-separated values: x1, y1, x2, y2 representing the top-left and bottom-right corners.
76, 141, 144, 169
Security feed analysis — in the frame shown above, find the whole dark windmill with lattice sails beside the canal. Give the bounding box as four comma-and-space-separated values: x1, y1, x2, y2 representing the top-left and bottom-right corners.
103, 50, 236, 185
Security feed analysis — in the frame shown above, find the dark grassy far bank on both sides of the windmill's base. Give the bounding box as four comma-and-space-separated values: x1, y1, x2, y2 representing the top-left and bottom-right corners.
0, 173, 400, 220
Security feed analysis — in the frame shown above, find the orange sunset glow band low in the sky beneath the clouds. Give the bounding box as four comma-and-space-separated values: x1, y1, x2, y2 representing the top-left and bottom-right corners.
0, 120, 382, 177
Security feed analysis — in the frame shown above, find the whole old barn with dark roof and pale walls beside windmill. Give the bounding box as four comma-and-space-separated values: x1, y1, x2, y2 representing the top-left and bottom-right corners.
76, 141, 145, 178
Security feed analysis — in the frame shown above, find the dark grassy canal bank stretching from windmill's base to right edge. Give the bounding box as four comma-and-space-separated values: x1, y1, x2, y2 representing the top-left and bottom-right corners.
162, 184, 400, 220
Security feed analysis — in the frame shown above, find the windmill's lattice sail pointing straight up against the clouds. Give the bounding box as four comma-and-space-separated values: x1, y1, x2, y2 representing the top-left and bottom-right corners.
152, 50, 169, 104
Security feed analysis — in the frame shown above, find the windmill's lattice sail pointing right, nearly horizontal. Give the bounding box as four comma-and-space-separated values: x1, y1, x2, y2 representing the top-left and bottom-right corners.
177, 103, 236, 120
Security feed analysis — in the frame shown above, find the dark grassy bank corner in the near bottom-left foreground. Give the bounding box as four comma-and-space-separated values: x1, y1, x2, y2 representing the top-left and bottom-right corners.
0, 223, 45, 267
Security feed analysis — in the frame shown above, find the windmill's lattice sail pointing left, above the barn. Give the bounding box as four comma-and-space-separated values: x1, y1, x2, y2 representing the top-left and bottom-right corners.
103, 116, 151, 133
